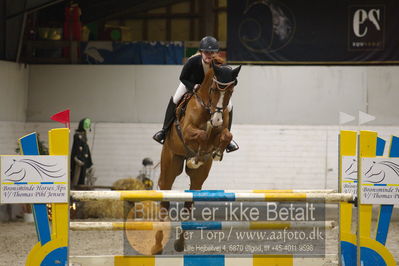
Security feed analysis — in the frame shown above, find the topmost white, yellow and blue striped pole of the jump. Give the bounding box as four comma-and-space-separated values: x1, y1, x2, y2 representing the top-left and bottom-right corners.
70, 190, 354, 203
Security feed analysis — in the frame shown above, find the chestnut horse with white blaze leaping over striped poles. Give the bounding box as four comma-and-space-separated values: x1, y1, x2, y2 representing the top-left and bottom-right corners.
152, 63, 241, 254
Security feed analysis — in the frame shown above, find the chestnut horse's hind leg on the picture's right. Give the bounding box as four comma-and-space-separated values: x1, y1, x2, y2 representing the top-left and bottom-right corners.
174, 159, 212, 252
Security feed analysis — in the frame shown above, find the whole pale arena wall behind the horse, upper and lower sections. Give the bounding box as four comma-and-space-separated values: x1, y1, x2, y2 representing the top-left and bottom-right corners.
0, 62, 399, 189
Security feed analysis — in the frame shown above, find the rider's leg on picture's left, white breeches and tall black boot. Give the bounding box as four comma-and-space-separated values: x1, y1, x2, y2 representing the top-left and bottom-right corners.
152, 82, 187, 144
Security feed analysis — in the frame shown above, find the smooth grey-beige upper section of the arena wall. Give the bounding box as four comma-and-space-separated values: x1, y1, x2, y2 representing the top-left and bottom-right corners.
27, 65, 399, 125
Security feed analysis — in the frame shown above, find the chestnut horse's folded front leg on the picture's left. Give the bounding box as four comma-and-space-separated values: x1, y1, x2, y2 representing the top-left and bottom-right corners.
183, 125, 208, 169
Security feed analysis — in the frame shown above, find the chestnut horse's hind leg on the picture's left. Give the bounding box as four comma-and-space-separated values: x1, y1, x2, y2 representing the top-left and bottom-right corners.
151, 147, 184, 254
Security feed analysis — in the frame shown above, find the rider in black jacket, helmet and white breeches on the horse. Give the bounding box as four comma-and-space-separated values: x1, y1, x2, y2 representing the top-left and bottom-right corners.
153, 36, 239, 152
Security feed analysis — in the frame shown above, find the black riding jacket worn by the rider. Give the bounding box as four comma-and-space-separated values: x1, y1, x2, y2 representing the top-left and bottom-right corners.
180, 54, 205, 91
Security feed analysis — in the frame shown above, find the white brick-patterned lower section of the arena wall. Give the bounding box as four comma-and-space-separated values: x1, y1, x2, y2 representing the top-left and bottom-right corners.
21, 122, 399, 189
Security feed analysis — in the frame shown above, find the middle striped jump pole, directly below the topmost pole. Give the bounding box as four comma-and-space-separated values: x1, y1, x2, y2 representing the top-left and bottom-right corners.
69, 221, 337, 231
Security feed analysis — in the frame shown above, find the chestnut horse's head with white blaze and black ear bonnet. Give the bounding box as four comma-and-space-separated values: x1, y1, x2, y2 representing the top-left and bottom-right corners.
209, 63, 241, 127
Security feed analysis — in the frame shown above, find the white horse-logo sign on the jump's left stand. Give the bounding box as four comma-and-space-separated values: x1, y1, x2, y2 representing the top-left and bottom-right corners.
0, 155, 69, 203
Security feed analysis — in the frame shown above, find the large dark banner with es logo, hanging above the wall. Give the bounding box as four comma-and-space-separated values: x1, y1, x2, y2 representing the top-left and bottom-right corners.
227, 0, 399, 64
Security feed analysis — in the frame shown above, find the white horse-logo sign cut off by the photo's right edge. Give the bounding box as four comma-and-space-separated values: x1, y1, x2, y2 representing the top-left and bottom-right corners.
360, 158, 399, 205
